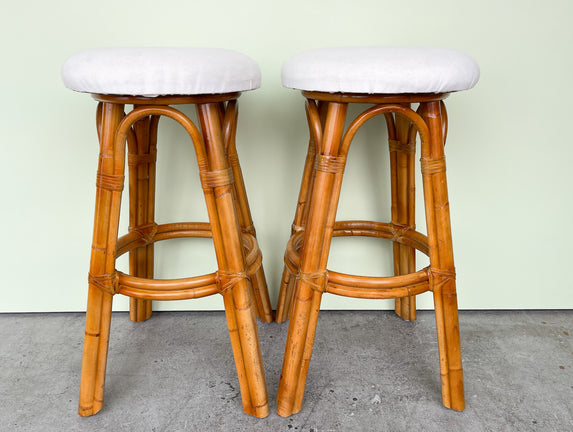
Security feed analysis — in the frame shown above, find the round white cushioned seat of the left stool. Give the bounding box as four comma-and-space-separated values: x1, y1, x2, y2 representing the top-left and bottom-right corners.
62, 48, 261, 96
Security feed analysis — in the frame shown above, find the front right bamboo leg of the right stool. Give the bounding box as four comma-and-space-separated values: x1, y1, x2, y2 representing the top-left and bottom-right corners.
422, 102, 465, 411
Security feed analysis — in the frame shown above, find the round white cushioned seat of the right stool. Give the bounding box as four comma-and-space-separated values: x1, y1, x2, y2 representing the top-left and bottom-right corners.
282, 47, 479, 94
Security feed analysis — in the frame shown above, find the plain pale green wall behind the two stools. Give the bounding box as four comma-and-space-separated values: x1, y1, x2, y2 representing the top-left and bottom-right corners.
0, 0, 573, 312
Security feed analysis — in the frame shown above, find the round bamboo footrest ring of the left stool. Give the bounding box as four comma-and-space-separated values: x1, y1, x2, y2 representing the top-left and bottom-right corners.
111, 222, 262, 300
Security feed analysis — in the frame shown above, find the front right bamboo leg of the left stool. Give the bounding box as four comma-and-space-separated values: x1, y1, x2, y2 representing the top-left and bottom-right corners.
197, 104, 269, 417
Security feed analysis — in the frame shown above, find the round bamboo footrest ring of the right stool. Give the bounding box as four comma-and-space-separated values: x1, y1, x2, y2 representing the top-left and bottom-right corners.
285, 221, 430, 299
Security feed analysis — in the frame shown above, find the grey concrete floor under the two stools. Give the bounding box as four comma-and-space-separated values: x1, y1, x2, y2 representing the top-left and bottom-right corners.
0, 311, 573, 432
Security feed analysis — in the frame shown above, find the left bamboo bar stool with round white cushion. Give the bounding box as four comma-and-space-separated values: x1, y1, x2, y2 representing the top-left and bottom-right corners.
62, 48, 273, 417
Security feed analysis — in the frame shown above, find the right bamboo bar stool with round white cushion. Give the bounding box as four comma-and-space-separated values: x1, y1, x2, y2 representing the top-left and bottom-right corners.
276, 47, 479, 416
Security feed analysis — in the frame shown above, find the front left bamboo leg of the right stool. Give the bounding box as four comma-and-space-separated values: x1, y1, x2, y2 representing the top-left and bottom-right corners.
277, 103, 347, 417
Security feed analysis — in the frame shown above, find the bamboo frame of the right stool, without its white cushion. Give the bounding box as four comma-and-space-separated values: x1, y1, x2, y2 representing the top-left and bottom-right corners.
276, 91, 464, 417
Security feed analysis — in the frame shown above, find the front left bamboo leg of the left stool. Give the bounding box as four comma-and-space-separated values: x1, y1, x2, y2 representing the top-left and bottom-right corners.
79, 103, 123, 416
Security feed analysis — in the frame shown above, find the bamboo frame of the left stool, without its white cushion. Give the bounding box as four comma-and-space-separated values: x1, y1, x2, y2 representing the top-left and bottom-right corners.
79, 92, 273, 417
